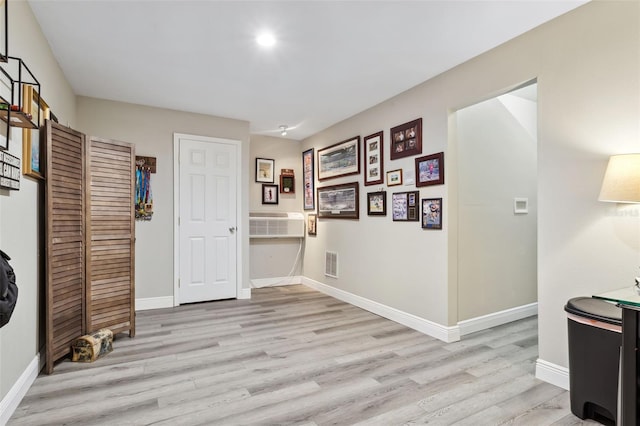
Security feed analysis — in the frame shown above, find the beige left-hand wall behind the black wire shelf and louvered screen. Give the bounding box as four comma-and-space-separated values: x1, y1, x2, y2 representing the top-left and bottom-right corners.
0, 1, 75, 404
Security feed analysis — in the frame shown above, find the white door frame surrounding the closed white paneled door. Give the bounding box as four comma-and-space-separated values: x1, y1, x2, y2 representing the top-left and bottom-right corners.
173, 133, 244, 306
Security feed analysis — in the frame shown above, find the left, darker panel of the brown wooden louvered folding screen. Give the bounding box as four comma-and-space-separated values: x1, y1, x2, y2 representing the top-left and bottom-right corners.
45, 120, 85, 374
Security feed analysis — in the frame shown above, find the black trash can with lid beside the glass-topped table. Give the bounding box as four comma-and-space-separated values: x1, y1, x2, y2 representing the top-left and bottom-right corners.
564, 297, 622, 424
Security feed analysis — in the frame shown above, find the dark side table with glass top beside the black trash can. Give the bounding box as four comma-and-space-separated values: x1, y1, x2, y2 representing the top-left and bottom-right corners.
593, 286, 640, 426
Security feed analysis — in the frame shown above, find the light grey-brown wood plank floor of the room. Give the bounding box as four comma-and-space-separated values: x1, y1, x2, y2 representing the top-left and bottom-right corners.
9, 285, 596, 426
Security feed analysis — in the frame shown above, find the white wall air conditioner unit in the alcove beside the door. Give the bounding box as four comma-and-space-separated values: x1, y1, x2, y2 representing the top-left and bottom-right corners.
249, 212, 305, 238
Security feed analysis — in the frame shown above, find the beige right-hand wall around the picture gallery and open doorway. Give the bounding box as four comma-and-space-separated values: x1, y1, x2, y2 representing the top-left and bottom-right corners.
302, 1, 640, 372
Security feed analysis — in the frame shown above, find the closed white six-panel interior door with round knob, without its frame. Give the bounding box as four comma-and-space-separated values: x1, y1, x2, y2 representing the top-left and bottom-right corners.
177, 136, 238, 303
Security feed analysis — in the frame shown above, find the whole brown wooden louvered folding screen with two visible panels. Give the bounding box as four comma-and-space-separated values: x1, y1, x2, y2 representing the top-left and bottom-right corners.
44, 120, 135, 374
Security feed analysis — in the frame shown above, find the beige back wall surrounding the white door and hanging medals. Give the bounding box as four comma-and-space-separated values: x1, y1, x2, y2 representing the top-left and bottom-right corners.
78, 97, 250, 299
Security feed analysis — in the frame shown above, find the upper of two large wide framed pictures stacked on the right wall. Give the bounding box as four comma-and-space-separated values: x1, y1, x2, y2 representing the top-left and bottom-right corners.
318, 136, 360, 180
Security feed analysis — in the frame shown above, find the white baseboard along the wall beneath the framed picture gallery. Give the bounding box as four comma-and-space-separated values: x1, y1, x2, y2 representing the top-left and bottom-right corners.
302, 277, 460, 343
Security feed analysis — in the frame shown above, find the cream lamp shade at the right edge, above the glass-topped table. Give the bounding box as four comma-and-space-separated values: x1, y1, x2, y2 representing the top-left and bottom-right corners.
598, 154, 640, 203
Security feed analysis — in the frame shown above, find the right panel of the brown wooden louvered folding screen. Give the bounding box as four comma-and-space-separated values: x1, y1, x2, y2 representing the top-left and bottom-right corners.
86, 137, 135, 337
